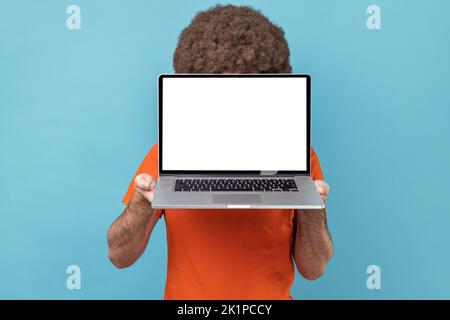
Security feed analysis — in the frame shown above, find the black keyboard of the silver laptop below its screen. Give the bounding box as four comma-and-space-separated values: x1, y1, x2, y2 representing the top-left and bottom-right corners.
175, 178, 298, 192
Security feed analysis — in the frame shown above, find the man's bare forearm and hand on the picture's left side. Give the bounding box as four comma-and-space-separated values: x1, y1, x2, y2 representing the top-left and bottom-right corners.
108, 174, 159, 268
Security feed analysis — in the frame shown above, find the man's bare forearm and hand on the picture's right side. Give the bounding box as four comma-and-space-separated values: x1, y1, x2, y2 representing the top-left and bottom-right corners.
294, 181, 333, 280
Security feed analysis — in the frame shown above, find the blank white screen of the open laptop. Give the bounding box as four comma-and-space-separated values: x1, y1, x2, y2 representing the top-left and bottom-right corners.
162, 77, 308, 171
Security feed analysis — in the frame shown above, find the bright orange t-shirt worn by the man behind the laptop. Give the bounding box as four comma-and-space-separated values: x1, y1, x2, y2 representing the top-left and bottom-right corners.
123, 144, 322, 299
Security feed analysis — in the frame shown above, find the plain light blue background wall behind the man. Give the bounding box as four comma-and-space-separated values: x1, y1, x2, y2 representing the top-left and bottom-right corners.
0, 0, 450, 299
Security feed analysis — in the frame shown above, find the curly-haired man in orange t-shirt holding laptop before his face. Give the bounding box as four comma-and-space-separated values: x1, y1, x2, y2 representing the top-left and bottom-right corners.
108, 5, 333, 299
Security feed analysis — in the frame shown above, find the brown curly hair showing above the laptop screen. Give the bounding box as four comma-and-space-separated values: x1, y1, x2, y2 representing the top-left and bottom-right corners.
173, 5, 292, 73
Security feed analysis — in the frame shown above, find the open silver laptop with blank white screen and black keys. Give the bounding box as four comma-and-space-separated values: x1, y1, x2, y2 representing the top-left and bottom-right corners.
152, 74, 325, 209
